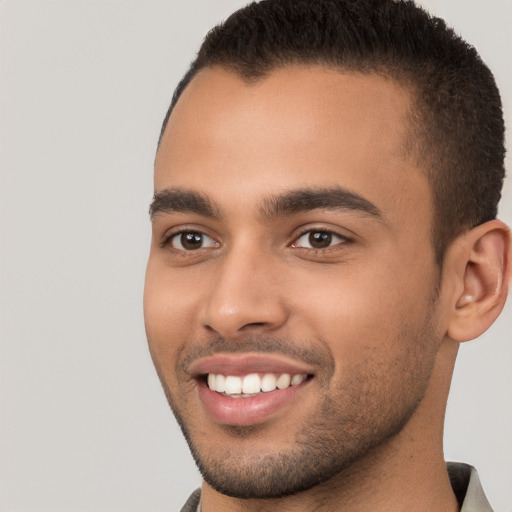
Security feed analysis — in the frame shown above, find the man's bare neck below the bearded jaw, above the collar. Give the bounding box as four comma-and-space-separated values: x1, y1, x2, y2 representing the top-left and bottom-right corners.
198, 343, 459, 512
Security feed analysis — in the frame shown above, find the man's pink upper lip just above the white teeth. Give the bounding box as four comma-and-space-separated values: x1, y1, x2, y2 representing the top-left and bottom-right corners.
188, 354, 314, 378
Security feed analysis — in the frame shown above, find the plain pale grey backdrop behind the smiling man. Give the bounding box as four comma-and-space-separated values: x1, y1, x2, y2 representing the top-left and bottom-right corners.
0, 0, 512, 512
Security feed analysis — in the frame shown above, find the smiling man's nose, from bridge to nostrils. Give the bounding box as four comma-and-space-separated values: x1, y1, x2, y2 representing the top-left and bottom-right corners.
202, 248, 288, 339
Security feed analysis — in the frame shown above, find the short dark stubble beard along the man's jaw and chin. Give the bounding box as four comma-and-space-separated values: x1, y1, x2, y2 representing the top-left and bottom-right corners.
164, 317, 438, 499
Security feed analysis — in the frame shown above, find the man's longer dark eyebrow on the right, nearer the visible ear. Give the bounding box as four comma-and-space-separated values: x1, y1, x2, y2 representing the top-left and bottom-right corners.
261, 187, 384, 220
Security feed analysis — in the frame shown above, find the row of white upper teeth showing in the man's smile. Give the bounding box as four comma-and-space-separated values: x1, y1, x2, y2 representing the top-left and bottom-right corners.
207, 373, 307, 398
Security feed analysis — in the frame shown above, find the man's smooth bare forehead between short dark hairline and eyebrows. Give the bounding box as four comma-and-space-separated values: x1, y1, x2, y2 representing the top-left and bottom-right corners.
155, 66, 429, 230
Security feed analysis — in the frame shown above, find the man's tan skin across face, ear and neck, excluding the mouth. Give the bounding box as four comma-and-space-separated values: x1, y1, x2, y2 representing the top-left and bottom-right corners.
144, 67, 510, 512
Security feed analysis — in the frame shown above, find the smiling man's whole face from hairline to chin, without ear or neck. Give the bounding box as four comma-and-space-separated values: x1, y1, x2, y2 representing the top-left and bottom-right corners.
144, 67, 440, 498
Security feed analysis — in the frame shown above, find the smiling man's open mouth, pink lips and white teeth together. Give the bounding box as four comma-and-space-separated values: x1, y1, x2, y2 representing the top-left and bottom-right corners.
190, 355, 314, 425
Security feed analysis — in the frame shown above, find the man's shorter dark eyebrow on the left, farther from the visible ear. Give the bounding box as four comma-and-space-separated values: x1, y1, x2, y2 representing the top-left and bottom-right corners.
149, 188, 220, 219
